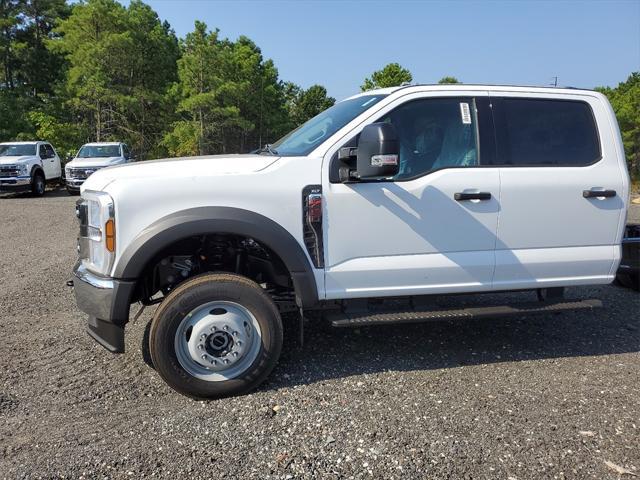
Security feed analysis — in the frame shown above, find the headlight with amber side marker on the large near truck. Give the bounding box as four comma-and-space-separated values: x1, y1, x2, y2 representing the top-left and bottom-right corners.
78, 190, 116, 275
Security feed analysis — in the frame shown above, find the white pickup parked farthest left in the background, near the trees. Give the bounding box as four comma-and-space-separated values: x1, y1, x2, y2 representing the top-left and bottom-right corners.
0, 142, 62, 197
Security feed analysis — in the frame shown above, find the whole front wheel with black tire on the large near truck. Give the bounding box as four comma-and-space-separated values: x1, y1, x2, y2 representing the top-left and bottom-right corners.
149, 273, 282, 399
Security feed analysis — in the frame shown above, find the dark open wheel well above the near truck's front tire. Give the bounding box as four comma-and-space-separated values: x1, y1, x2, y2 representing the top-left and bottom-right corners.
134, 233, 295, 310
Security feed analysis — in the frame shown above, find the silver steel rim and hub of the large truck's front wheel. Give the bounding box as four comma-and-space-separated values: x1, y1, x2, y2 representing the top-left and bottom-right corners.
175, 301, 261, 381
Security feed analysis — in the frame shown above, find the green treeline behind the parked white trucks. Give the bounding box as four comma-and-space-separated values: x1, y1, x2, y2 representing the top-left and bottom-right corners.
0, 0, 640, 176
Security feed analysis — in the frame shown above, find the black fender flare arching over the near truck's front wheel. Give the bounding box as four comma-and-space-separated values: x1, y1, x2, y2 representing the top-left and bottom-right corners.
114, 207, 318, 308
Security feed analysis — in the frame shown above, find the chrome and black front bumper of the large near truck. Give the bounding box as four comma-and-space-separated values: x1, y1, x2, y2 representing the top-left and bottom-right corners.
73, 262, 135, 353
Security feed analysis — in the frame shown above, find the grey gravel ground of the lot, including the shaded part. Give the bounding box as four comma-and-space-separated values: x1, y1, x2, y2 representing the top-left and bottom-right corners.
0, 192, 640, 479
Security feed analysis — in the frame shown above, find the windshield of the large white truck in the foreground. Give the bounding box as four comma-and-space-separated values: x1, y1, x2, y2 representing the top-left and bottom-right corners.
270, 95, 386, 156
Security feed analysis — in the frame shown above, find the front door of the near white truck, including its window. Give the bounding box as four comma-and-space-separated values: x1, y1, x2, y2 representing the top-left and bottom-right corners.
323, 92, 500, 299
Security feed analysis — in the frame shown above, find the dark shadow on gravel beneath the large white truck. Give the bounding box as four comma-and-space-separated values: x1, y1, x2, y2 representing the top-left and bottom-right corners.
261, 287, 640, 390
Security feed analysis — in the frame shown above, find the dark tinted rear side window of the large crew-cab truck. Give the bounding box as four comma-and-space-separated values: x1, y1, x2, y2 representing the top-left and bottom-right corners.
498, 98, 600, 166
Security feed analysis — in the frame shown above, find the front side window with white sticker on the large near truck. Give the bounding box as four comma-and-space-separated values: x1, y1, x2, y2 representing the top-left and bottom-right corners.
379, 98, 479, 180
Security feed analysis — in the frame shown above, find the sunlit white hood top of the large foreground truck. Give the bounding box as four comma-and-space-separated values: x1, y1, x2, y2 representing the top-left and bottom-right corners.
83, 154, 280, 191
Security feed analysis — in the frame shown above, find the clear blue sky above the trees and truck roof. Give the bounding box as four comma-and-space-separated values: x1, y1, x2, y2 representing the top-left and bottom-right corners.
122, 0, 640, 99
